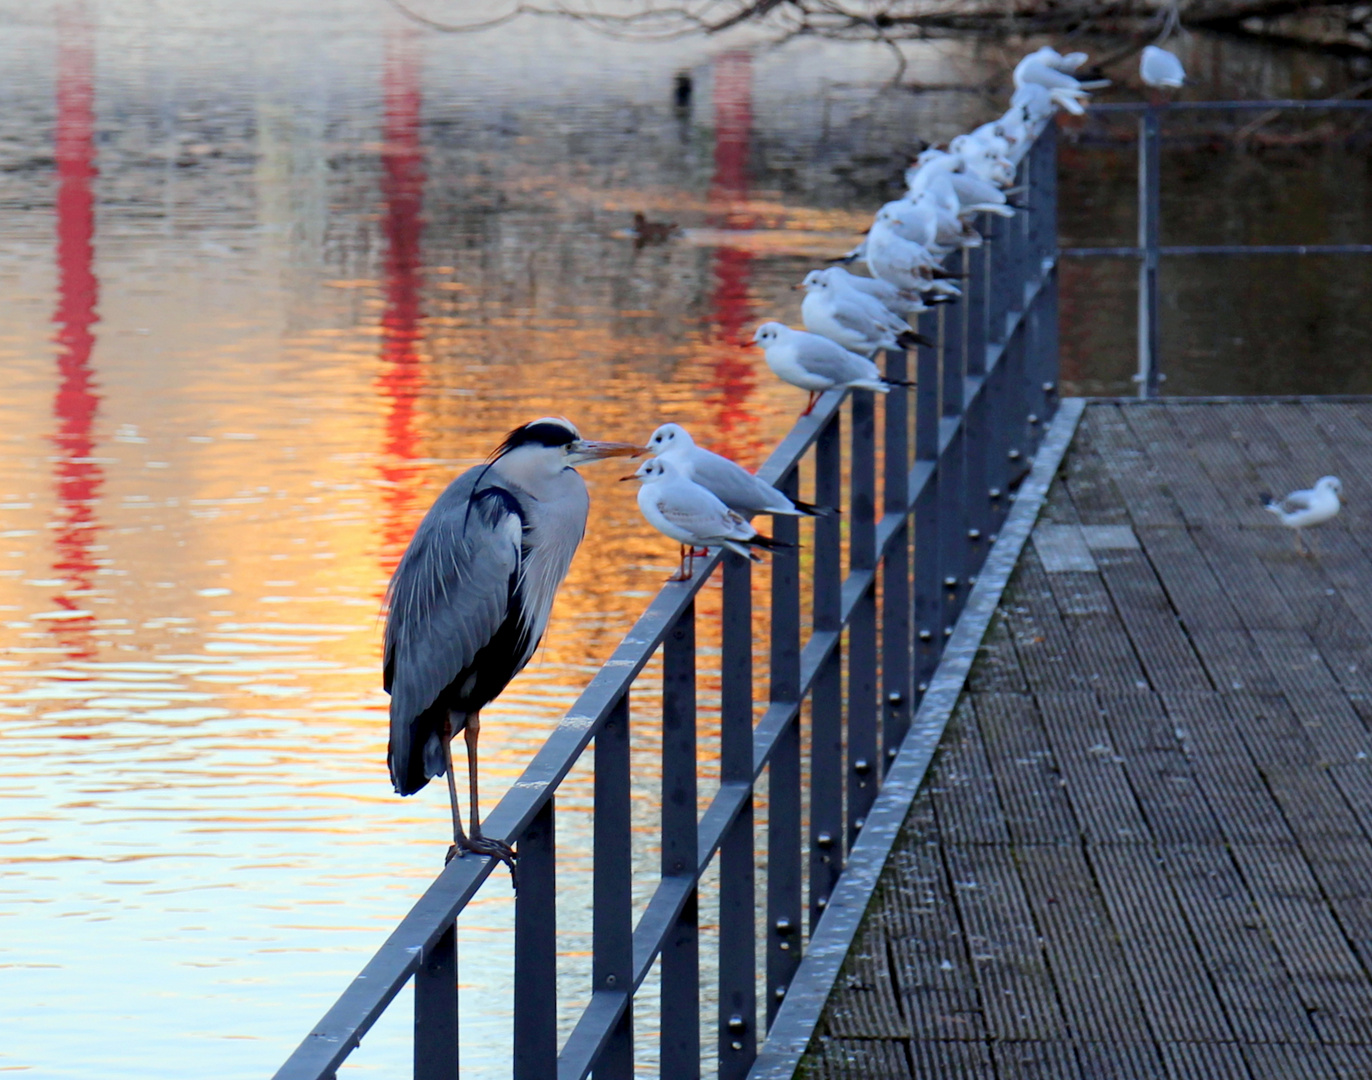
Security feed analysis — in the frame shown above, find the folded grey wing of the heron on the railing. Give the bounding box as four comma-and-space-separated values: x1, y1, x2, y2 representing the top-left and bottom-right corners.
386, 468, 524, 740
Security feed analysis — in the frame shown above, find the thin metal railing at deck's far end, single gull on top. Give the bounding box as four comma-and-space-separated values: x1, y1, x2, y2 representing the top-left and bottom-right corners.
1061, 97, 1372, 398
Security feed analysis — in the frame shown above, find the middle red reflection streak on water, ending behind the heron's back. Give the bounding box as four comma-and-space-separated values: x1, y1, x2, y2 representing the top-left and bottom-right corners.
376, 32, 424, 576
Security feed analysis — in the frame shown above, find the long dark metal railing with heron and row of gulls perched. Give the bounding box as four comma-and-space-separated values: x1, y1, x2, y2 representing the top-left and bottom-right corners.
276, 125, 1058, 1080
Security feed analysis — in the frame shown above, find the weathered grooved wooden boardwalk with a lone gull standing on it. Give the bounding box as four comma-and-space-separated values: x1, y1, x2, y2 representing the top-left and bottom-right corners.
800, 402, 1372, 1080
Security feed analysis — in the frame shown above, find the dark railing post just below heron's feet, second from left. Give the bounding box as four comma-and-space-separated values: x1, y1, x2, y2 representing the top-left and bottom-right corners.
515, 796, 557, 1080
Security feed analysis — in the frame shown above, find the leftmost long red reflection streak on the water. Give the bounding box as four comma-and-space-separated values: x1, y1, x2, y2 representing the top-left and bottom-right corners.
52, 5, 104, 660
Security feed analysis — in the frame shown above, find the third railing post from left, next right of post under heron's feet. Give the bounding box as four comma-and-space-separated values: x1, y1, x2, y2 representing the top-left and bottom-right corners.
591, 693, 634, 1080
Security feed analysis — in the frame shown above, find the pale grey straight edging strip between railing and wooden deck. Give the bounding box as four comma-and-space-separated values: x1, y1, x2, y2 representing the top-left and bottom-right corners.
748, 398, 1087, 1080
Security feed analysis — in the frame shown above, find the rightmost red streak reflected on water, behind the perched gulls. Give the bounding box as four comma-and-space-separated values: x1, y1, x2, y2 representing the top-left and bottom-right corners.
705, 51, 761, 461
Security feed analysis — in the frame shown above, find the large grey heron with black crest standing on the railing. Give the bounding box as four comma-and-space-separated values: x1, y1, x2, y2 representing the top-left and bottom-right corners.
383, 417, 642, 876
